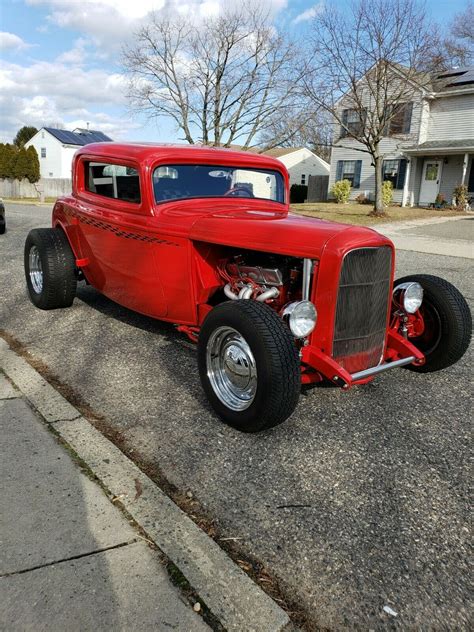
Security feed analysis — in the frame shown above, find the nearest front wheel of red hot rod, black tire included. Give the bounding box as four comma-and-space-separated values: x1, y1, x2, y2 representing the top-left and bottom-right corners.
198, 300, 301, 432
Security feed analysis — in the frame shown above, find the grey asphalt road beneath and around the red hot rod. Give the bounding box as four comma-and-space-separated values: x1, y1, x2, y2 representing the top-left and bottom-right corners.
0, 204, 474, 630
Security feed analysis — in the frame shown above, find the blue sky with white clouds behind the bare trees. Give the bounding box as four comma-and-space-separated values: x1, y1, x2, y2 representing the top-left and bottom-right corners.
0, 0, 467, 142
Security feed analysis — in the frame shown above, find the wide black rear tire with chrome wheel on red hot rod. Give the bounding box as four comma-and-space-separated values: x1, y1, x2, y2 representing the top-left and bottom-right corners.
24, 228, 77, 310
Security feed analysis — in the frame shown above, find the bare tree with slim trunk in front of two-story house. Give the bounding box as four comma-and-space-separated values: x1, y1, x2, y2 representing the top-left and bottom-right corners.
305, 0, 429, 216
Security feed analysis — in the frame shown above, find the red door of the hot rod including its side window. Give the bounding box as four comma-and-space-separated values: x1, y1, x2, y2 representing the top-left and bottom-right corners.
77, 157, 167, 317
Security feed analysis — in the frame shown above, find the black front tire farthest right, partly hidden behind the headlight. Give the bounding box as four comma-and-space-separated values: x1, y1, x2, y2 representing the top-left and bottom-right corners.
394, 274, 472, 373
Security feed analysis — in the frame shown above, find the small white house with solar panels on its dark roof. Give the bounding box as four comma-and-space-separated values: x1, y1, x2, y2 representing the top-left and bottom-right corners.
25, 127, 112, 179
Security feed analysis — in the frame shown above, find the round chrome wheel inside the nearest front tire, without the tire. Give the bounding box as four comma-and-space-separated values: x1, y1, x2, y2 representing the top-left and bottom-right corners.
206, 327, 257, 411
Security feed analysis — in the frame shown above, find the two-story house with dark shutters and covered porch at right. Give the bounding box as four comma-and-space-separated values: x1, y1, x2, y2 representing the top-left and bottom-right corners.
329, 67, 474, 206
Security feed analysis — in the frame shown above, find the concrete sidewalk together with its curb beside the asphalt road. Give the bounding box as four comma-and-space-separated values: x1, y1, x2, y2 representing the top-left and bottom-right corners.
0, 338, 294, 632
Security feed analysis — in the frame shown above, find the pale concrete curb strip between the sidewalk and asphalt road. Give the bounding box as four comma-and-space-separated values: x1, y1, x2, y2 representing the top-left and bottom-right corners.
0, 338, 290, 632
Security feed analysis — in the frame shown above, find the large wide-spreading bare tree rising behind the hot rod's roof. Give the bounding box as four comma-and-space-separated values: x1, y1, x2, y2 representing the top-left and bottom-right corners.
124, 1, 297, 148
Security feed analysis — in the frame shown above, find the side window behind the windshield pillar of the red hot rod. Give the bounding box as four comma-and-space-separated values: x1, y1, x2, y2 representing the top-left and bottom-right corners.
84, 162, 141, 204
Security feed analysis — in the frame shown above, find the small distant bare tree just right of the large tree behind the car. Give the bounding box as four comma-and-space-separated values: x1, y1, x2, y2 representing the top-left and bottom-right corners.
259, 107, 333, 161
